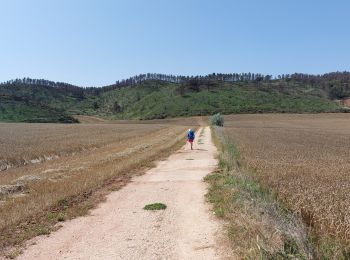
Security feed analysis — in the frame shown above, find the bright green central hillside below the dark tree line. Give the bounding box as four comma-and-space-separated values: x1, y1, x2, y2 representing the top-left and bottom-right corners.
102, 82, 339, 119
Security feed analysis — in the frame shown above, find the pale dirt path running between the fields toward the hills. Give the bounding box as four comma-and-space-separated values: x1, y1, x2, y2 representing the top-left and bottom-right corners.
19, 127, 221, 259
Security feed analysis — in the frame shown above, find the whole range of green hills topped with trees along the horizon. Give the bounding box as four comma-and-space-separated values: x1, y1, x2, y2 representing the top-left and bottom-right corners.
0, 73, 350, 123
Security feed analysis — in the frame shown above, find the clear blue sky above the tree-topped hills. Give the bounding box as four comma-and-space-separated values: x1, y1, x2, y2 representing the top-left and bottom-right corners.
0, 0, 350, 86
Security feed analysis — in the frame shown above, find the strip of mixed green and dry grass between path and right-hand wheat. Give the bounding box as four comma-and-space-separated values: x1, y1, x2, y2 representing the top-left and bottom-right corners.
206, 127, 312, 259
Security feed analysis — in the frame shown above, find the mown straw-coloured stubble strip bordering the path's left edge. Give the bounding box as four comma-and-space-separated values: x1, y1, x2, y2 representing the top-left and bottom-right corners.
0, 126, 186, 239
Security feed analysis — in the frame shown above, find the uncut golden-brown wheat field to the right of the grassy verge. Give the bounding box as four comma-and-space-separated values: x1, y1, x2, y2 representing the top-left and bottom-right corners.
225, 114, 350, 243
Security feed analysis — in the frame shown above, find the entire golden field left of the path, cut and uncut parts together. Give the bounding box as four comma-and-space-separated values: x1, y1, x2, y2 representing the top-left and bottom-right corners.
0, 120, 197, 254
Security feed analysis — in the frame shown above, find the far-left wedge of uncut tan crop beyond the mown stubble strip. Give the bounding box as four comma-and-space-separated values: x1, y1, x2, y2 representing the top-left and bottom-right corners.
0, 123, 167, 170
